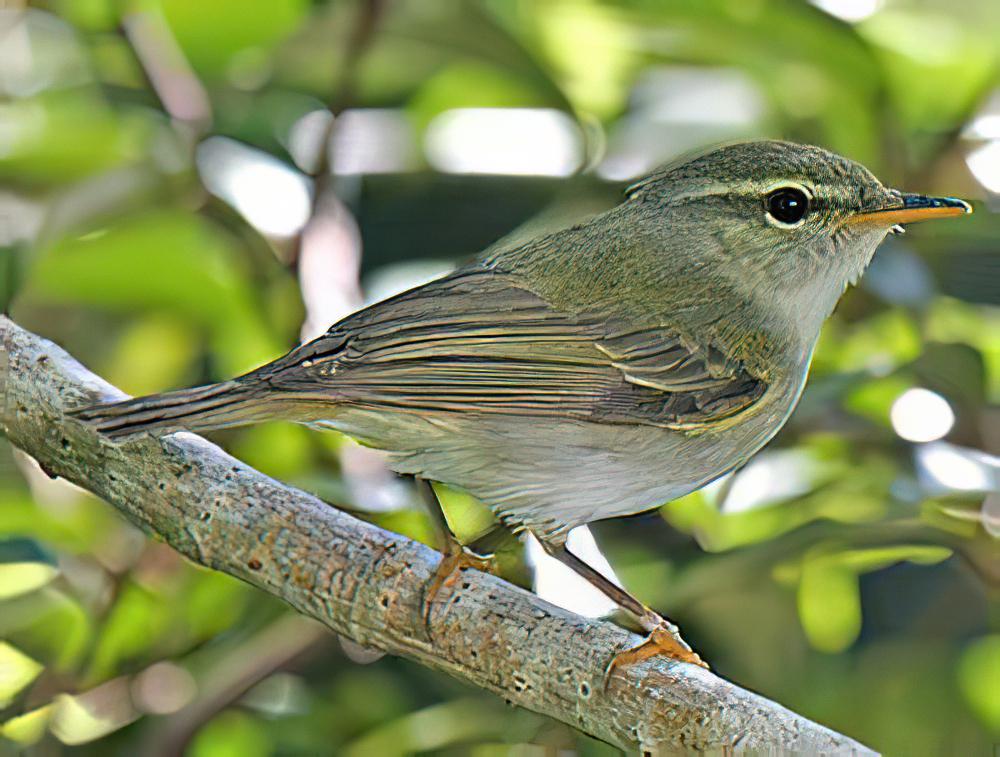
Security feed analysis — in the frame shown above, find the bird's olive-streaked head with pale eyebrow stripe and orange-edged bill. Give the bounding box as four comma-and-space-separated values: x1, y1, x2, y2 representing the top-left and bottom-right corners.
627, 140, 972, 330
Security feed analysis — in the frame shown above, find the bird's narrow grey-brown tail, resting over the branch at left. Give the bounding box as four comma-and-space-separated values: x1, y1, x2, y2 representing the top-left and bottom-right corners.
72, 374, 282, 439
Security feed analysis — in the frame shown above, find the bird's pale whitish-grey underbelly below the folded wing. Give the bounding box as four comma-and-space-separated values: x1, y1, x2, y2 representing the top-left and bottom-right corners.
314, 392, 787, 540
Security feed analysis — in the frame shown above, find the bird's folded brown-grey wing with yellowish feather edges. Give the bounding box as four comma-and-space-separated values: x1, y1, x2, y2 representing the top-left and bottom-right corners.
278, 267, 767, 428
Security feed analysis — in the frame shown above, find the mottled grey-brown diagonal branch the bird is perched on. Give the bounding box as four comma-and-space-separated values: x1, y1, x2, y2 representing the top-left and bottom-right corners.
0, 317, 873, 755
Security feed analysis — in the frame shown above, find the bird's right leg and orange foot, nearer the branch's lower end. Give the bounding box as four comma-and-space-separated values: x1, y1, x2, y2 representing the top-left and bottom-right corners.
542, 541, 708, 683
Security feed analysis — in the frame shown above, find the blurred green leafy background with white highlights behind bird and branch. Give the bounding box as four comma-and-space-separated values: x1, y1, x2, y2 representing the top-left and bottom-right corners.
0, 0, 1000, 757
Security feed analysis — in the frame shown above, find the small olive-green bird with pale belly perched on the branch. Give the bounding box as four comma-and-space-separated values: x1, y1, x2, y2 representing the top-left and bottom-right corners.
76, 140, 972, 664
